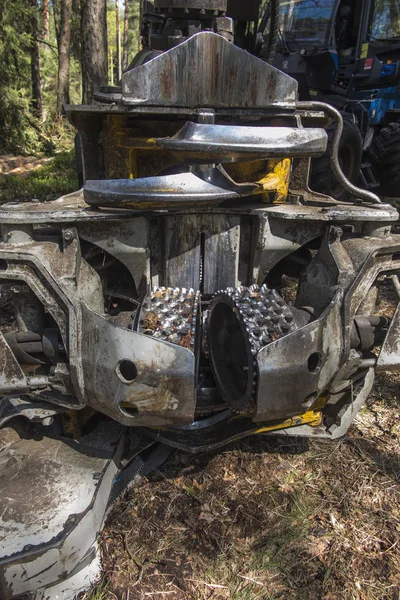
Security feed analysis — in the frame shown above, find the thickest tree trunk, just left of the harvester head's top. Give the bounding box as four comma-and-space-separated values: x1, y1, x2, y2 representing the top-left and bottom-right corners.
81, 0, 107, 104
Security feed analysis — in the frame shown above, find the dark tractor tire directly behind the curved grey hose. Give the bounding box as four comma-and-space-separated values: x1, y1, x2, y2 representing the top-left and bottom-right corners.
310, 117, 362, 201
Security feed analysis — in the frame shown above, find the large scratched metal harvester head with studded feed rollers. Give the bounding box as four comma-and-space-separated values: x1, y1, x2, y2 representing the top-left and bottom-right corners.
0, 0, 400, 600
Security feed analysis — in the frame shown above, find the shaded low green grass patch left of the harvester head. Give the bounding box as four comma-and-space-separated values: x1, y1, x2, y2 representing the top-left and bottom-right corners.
0, 150, 78, 202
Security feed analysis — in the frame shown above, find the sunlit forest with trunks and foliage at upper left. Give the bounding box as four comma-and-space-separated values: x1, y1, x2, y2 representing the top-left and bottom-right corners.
0, 0, 141, 156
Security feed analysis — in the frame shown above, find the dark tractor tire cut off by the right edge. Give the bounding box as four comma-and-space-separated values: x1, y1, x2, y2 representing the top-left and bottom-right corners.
368, 123, 400, 198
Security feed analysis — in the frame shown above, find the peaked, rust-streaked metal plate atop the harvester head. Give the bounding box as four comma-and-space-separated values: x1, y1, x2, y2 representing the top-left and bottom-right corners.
122, 32, 297, 109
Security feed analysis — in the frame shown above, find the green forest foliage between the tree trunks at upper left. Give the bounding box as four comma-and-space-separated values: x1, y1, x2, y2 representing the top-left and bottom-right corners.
0, 0, 140, 156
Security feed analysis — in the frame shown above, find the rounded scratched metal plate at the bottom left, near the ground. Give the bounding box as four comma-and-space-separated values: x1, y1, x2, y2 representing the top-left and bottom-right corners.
0, 422, 122, 600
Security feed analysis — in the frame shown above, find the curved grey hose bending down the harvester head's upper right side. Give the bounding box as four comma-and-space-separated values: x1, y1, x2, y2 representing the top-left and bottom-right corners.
297, 101, 382, 204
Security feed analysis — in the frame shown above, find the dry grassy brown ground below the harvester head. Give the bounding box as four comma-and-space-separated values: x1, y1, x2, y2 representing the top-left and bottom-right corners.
86, 374, 400, 600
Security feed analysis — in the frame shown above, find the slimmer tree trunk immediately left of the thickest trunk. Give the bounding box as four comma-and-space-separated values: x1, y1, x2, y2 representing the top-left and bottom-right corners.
57, 0, 72, 114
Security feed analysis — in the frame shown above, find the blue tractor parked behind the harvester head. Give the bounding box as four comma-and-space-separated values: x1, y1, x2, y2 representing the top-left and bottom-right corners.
272, 0, 400, 200
